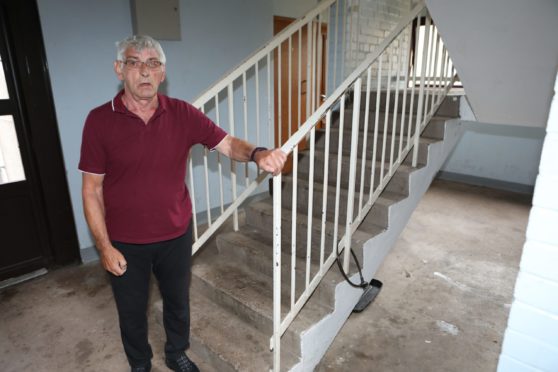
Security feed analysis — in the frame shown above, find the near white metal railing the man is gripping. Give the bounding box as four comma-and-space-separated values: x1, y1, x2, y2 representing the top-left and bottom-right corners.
270, 3, 456, 371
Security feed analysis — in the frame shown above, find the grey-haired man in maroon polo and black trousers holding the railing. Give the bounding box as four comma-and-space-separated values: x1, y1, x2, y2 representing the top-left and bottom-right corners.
79, 36, 286, 372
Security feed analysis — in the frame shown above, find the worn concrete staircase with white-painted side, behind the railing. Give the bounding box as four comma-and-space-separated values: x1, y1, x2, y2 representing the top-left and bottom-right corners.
155, 92, 461, 372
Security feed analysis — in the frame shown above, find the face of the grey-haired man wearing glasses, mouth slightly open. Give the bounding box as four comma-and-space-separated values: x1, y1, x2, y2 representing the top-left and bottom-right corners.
114, 48, 165, 100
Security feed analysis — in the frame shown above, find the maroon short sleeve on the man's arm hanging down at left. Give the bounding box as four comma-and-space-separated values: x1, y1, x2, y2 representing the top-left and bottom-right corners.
78, 113, 106, 174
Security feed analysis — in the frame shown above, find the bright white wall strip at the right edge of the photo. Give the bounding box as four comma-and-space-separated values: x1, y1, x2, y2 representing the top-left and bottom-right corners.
498, 77, 558, 372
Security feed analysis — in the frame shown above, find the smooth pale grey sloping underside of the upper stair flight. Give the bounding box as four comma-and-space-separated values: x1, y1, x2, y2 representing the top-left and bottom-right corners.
426, 0, 558, 128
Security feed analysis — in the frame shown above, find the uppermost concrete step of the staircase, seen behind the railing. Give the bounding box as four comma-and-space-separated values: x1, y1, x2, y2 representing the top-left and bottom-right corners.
361, 89, 459, 117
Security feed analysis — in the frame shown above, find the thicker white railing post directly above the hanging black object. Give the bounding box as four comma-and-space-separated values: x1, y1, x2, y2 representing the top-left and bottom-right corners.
343, 77, 362, 273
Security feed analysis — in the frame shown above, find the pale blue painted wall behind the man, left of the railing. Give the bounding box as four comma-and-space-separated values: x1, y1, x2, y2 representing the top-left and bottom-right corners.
37, 0, 273, 248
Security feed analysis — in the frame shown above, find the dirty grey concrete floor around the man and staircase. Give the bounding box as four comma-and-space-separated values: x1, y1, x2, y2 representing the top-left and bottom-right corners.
0, 181, 530, 372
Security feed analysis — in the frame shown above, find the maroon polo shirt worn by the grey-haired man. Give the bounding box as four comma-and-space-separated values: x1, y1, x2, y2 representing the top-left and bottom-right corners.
79, 92, 226, 244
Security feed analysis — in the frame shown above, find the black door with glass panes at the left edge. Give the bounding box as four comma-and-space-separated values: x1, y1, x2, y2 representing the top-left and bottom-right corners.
0, 0, 79, 280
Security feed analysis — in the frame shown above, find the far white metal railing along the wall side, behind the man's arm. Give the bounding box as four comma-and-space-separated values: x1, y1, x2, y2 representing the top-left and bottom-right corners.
187, 0, 358, 253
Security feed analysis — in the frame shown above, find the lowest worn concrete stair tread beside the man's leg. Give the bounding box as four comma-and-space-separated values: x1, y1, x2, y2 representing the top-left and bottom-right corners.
190, 286, 299, 372
